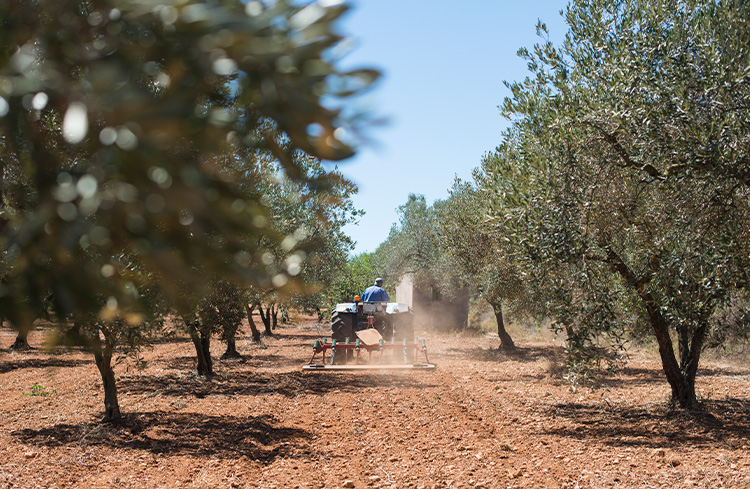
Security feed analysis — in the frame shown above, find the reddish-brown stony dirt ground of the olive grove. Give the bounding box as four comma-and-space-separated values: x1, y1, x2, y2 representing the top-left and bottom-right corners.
0, 322, 750, 489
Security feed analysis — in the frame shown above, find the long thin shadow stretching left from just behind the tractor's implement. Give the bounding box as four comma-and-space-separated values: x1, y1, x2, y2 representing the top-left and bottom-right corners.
118, 371, 437, 398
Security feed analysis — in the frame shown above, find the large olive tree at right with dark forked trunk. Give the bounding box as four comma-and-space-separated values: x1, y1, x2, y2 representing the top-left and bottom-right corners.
479, 0, 750, 407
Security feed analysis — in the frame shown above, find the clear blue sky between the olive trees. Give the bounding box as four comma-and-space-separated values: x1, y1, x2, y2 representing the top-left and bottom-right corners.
330, 0, 567, 253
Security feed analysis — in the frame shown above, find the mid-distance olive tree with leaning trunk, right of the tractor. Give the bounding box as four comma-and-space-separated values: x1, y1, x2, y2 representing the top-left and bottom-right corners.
377, 187, 533, 349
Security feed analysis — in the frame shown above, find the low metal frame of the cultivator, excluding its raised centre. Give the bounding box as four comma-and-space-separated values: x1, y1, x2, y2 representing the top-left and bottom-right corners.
302, 338, 435, 371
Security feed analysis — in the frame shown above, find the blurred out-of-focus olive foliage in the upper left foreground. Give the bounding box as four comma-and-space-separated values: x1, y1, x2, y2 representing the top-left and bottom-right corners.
0, 0, 377, 325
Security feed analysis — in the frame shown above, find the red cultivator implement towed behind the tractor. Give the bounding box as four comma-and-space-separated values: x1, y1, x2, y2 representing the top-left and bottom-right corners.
302, 329, 435, 370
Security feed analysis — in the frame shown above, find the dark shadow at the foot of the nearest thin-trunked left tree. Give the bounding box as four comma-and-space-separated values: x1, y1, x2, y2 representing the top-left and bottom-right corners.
13, 411, 311, 463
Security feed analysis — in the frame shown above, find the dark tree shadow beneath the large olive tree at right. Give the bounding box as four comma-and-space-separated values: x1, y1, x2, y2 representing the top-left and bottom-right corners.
540, 399, 750, 448
